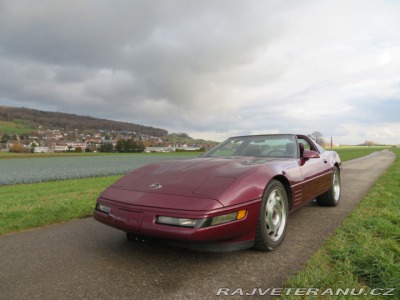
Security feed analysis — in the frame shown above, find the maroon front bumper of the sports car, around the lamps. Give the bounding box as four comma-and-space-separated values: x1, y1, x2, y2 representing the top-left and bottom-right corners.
93, 197, 260, 251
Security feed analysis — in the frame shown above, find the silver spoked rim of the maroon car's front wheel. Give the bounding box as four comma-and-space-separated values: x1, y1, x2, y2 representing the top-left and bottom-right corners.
265, 189, 287, 241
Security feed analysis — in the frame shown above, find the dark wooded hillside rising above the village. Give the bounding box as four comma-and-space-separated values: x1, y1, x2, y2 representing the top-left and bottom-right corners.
0, 106, 168, 137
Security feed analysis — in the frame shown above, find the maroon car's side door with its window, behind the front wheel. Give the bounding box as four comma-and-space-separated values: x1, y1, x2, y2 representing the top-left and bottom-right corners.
297, 136, 332, 202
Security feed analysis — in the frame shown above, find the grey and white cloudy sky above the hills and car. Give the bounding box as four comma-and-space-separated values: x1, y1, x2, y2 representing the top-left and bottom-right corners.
0, 0, 400, 144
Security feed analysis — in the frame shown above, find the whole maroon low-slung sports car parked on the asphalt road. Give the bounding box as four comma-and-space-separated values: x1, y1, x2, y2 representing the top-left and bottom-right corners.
94, 134, 341, 251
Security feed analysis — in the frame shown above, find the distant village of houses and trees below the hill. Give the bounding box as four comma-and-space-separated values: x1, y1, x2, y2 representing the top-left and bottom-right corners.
0, 127, 215, 153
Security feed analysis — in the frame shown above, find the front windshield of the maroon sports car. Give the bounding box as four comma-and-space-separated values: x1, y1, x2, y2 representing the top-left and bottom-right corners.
203, 135, 297, 158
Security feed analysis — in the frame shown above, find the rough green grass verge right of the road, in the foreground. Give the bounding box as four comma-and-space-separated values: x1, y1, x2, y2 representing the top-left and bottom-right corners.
286, 149, 400, 299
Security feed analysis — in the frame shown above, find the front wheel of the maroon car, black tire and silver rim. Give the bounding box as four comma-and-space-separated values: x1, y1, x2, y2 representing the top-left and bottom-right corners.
254, 180, 289, 251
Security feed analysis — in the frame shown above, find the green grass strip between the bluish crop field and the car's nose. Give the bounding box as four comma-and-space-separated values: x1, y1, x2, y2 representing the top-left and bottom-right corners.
0, 176, 121, 235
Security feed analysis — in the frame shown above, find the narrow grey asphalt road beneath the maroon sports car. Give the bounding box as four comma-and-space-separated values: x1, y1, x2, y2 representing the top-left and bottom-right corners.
0, 151, 395, 299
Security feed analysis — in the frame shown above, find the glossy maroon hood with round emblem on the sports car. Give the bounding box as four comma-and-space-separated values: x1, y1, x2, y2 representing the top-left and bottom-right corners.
104, 157, 282, 200
